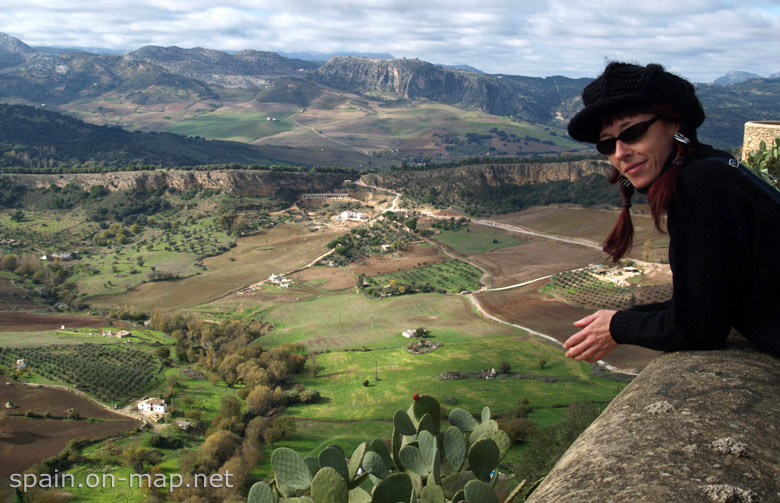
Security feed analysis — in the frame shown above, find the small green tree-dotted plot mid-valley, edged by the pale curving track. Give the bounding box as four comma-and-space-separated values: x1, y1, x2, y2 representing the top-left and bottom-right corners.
366, 260, 482, 292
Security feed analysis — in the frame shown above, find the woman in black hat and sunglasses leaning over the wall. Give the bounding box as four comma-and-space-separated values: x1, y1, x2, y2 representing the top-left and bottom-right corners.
564, 63, 780, 362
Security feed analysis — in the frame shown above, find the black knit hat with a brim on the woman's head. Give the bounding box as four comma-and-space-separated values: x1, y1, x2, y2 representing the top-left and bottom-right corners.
569, 62, 704, 143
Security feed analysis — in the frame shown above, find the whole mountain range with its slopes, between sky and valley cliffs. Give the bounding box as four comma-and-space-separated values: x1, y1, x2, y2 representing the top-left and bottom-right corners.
0, 33, 780, 165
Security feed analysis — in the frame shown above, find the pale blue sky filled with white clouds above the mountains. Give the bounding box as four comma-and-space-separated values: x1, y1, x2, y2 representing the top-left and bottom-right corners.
0, 0, 780, 82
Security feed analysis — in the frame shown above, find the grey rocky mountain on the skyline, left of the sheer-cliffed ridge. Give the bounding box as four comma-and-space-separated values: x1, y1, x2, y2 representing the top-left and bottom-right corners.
127, 46, 318, 87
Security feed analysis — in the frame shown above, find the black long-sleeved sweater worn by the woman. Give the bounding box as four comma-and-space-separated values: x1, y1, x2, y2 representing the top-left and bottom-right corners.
610, 148, 780, 357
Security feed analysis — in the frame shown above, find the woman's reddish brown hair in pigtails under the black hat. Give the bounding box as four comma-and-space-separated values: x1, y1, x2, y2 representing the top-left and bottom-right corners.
602, 105, 698, 262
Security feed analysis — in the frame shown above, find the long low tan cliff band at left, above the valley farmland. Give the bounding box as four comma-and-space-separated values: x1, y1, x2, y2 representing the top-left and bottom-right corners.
0, 170, 344, 196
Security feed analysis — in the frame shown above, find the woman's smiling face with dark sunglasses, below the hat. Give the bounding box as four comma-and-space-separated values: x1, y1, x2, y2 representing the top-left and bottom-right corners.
599, 113, 679, 189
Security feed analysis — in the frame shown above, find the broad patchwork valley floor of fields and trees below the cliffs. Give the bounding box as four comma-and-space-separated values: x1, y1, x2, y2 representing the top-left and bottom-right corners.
0, 168, 670, 501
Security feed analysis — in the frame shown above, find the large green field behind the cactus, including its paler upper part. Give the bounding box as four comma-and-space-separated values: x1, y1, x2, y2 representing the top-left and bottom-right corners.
250, 294, 624, 474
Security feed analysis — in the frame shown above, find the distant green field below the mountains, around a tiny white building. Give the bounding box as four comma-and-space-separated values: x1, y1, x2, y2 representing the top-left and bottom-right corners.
168, 108, 293, 143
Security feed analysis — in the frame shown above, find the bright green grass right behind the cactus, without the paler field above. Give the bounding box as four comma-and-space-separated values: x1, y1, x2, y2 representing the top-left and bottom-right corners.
260, 331, 624, 474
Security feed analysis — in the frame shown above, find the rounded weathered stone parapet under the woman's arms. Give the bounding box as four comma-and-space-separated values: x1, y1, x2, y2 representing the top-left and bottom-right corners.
528, 336, 780, 503
